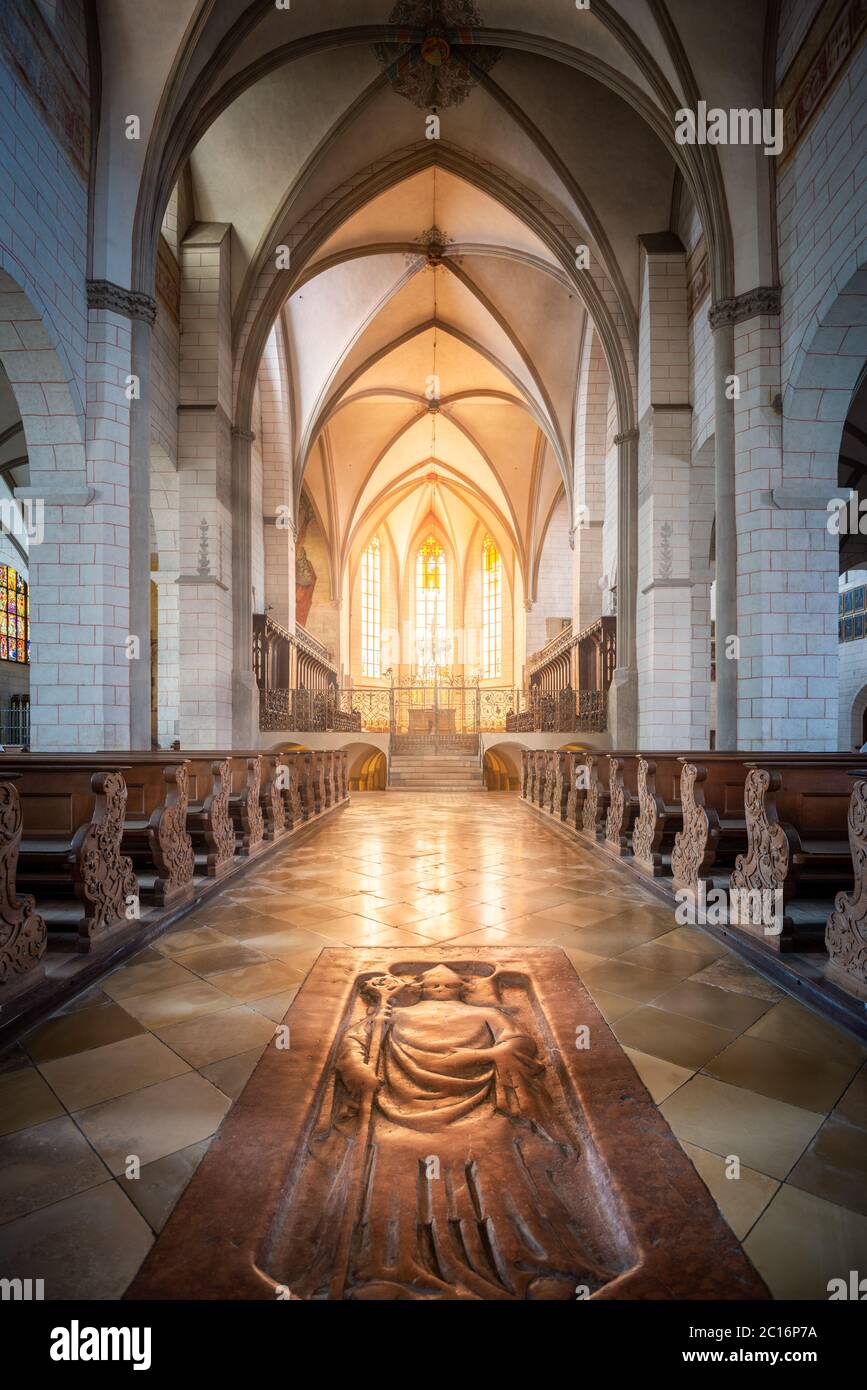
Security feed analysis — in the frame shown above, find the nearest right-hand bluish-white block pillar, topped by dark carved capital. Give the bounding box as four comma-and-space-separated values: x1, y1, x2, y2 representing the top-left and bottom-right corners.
717, 288, 850, 752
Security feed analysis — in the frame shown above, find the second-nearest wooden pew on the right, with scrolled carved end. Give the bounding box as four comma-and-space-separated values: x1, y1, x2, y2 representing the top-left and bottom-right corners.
729, 753, 864, 952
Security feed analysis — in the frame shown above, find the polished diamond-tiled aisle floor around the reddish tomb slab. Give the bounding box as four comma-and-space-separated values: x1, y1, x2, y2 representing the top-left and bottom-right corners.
0, 792, 867, 1298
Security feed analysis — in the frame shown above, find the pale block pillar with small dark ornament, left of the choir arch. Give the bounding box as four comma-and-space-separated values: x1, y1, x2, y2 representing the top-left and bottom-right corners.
178, 224, 233, 748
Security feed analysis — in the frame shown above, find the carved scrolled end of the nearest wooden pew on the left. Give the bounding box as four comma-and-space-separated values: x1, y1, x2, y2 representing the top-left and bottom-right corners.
0, 778, 49, 1006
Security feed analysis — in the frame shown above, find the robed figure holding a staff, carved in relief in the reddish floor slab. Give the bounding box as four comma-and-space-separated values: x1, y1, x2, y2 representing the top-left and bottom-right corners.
267, 965, 618, 1301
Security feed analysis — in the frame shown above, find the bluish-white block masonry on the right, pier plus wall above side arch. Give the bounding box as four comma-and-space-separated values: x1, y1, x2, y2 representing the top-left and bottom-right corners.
735, 47, 867, 751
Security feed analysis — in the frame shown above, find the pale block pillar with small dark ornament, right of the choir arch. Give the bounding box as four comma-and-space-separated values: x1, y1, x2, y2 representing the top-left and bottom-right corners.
638, 244, 710, 749
